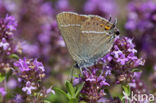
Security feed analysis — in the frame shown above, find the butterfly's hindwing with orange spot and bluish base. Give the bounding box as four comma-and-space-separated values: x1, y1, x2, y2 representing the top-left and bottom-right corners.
79, 15, 115, 67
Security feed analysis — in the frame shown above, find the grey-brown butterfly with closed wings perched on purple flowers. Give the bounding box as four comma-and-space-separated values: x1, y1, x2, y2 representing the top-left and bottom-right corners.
56, 12, 119, 68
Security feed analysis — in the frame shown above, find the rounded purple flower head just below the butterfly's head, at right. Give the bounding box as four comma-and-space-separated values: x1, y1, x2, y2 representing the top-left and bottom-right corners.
101, 37, 145, 83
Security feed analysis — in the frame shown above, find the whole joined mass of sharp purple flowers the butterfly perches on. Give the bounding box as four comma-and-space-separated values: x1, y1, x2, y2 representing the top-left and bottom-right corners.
73, 37, 144, 102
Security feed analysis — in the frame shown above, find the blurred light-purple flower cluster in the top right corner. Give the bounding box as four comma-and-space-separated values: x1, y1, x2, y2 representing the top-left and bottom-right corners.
125, 0, 156, 32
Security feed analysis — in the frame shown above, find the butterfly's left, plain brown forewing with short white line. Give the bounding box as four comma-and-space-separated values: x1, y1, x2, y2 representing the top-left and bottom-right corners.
57, 12, 87, 62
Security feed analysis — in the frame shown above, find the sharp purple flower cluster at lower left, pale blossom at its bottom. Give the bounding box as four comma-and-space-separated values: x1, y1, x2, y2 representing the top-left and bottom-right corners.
14, 58, 45, 95
